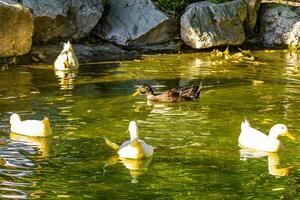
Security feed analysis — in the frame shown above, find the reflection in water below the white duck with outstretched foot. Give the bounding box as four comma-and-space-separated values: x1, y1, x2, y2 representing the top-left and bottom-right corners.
103, 155, 152, 183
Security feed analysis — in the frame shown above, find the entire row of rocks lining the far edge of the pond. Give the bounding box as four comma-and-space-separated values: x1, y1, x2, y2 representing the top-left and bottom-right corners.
0, 0, 300, 64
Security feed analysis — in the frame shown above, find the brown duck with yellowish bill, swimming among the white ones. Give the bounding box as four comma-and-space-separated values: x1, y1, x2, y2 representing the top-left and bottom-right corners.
133, 82, 202, 103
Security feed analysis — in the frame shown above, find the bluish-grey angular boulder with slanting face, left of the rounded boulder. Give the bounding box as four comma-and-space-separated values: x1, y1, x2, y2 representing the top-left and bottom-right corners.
94, 0, 177, 46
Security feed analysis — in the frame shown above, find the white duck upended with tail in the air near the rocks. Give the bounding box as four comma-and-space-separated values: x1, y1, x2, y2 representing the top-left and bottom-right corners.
54, 41, 79, 70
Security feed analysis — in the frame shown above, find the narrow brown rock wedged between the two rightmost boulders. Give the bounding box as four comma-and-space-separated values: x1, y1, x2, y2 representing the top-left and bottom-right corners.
244, 0, 261, 35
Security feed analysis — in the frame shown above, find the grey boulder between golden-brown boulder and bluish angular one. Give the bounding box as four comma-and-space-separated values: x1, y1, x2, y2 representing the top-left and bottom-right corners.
23, 0, 104, 42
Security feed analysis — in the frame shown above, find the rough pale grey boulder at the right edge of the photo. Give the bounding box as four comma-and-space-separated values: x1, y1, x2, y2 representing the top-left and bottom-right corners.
260, 4, 300, 47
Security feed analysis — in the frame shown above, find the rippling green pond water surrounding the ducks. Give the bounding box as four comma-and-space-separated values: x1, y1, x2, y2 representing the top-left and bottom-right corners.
0, 51, 300, 199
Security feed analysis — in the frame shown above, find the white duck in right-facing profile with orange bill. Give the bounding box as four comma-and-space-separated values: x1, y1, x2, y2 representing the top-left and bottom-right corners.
238, 120, 295, 152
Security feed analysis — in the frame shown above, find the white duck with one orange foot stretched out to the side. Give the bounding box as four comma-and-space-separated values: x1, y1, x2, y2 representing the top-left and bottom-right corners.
104, 121, 153, 159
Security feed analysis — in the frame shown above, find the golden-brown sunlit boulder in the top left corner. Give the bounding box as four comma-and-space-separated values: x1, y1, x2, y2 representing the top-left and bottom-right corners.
0, 1, 33, 57
